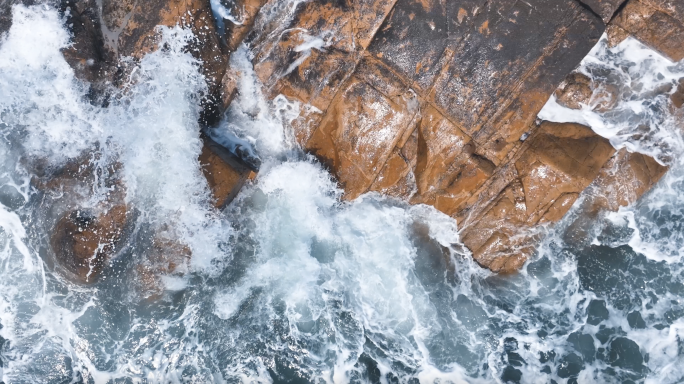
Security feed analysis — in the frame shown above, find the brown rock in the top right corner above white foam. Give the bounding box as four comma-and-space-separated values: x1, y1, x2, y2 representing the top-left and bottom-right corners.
613, 0, 684, 61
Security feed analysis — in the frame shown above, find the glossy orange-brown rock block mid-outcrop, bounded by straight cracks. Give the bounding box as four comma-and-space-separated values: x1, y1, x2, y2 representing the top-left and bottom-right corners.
306, 60, 418, 199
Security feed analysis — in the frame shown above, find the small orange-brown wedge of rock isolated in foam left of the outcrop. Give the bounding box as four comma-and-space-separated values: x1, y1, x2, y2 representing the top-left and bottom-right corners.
199, 136, 256, 209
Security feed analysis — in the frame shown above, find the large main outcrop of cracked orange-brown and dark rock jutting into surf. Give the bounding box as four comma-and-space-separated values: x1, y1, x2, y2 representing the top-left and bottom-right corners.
236, 0, 613, 271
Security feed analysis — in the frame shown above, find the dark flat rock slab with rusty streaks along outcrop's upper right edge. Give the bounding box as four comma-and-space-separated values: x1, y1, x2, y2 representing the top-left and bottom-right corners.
428, 0, 604, 164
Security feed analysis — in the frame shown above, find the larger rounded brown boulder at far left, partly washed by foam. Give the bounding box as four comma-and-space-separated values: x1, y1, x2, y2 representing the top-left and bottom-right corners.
38, 154, 129, 284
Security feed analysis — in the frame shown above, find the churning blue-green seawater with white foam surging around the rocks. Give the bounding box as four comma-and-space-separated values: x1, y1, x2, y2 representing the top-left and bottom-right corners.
0, 6, 684, 384
